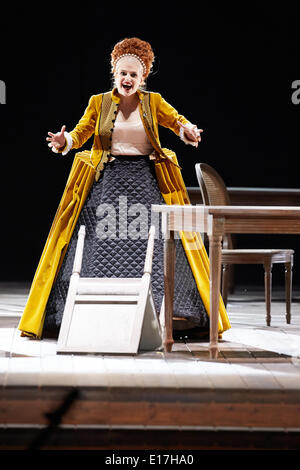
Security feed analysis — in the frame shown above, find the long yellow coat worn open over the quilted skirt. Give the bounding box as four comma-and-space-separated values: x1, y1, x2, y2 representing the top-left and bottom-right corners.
19, 89, 230, 338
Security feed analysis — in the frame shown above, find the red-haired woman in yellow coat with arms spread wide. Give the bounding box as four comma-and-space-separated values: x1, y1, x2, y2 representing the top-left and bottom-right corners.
19, 38, 230, 338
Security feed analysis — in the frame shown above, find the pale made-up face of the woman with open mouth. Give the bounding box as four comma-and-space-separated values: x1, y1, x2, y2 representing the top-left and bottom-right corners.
114, 57, 143, 96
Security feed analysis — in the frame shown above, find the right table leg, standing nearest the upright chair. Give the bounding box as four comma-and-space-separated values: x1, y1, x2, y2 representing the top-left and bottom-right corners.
209, 235, 222, 359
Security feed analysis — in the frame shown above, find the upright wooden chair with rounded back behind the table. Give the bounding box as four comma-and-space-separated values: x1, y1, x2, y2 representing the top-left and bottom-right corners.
195, 163, 294, 326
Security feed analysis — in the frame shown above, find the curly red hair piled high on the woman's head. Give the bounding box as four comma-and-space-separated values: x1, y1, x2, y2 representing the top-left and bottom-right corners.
111, 38, 154, 78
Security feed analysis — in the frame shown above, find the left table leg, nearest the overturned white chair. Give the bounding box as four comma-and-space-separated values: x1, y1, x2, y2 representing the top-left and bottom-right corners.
164, 230, 175, 352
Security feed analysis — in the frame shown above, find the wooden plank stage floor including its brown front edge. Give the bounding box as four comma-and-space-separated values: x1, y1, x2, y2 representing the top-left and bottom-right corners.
0, 283, 300, 448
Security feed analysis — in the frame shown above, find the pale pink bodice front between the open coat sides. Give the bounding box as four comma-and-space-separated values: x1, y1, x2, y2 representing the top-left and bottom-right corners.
111, 118, 153, 155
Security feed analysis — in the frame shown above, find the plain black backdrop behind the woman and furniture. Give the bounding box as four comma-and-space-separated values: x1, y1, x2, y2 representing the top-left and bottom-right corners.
0, 1, 300, 283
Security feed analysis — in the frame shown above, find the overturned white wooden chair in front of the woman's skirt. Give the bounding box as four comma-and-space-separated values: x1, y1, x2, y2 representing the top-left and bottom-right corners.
57, 225, 162, 354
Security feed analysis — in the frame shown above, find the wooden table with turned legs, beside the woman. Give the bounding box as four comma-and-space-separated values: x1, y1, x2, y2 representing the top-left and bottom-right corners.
152, 205, 300, 359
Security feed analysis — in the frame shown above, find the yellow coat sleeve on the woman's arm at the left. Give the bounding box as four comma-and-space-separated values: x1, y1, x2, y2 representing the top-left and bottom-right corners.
70, 95, 99, 149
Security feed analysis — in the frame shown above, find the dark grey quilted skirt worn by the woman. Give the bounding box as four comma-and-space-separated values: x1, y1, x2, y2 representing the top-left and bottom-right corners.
43, 156, 209, 336
